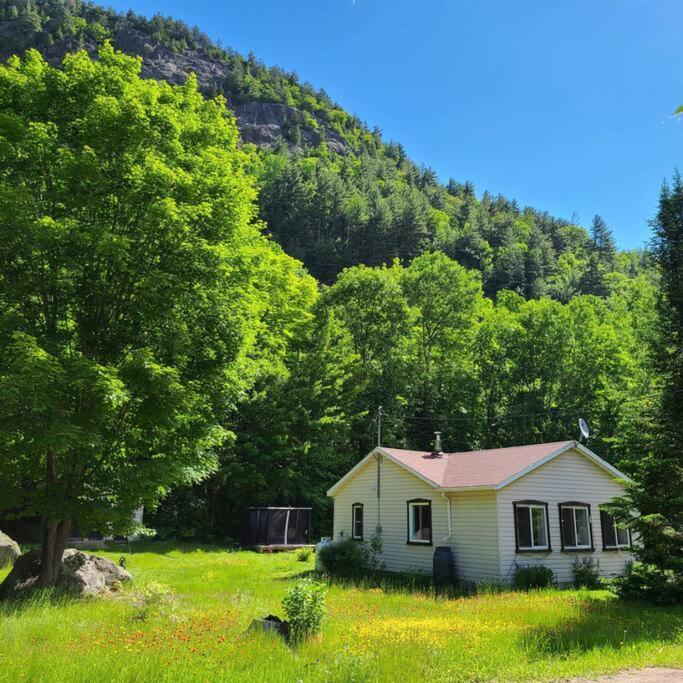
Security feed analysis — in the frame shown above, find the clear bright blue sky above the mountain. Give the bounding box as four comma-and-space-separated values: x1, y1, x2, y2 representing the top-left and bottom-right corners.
112, 0, 683, 248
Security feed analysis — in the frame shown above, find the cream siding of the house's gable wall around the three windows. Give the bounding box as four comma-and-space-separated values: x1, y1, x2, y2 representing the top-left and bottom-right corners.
497, 451, 632, 583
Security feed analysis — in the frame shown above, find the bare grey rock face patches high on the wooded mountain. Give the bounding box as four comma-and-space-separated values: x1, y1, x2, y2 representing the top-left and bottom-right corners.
0, 21, 348, 154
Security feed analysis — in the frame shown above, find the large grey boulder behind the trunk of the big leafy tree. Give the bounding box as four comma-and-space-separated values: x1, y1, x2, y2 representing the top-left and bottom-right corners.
0, 548, 132, 600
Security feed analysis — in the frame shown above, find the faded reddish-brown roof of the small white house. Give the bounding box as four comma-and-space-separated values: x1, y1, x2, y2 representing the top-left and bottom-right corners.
381, 441, 574, 488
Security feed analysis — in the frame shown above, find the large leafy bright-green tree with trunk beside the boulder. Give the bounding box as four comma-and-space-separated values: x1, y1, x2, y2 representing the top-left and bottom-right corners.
0, 45, 269, 586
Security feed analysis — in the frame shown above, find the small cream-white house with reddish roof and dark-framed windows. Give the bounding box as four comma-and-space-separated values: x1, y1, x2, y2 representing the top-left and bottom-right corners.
328, 441, 631, 583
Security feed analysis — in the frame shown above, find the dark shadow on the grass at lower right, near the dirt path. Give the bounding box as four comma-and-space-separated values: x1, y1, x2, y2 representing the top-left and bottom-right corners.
522, 598, 683, 657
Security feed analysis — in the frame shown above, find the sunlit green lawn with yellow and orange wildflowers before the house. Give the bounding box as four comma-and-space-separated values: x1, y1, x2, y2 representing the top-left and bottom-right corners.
0, 544, 683, 682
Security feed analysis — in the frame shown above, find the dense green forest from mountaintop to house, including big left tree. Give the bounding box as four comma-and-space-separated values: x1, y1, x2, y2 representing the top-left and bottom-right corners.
0, 0, 681, 600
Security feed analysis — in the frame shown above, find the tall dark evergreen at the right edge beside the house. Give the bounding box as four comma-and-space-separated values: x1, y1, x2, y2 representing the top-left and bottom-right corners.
609, 174, 683, 602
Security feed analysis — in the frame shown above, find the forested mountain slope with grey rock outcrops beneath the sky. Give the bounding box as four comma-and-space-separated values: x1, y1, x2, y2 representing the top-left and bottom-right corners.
0, 0, 648, 292
